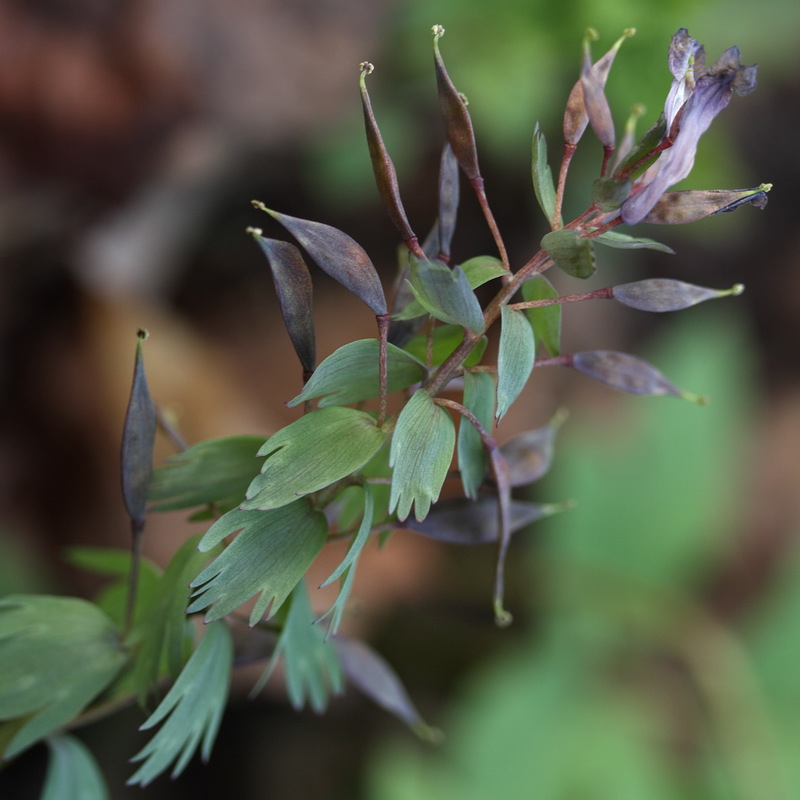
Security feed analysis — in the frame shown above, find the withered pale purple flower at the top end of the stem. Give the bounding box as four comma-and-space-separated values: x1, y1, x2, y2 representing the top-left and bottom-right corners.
620, 28, 756, 225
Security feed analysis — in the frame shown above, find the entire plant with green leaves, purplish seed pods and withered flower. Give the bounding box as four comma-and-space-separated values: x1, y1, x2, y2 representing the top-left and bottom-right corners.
0, 25, 769, 797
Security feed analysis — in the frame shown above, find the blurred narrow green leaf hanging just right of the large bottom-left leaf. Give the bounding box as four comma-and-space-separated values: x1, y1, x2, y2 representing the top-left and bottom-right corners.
133, 536, 216, 703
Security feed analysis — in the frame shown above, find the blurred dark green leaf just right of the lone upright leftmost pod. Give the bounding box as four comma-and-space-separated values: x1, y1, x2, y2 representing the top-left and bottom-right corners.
150, 436, 264, 511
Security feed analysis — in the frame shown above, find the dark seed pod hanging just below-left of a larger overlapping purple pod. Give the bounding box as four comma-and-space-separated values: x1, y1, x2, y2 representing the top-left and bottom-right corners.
247, 228, 317, 374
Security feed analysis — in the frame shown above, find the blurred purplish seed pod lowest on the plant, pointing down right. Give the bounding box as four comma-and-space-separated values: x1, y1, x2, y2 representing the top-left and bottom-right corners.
333, 637, 442, 742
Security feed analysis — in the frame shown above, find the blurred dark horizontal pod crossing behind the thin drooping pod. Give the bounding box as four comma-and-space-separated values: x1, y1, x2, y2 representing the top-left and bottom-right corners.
403, 495, 567, 545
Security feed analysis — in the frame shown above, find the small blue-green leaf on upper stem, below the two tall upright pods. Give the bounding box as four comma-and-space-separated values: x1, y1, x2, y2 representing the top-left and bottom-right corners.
411, 260, 483, 333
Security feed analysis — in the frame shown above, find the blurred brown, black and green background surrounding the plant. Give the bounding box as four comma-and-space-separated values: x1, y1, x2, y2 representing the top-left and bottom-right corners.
0, 0, 800, 800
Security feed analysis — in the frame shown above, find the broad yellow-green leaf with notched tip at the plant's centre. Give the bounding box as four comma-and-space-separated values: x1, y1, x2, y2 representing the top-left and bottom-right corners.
241, 406, 387, 511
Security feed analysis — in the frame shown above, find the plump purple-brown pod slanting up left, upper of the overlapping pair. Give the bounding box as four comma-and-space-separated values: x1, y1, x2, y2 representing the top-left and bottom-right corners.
256, 203, 387, 315
